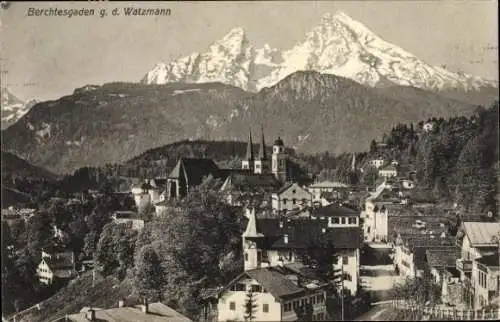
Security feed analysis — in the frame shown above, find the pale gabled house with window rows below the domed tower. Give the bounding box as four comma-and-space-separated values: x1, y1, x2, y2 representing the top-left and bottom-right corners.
272, 183, 313, 213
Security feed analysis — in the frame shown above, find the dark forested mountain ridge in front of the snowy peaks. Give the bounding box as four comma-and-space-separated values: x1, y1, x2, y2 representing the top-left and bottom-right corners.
2, 71, 482, 173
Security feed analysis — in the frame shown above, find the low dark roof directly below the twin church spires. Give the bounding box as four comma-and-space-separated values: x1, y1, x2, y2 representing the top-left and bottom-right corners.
222, 171, 281, 191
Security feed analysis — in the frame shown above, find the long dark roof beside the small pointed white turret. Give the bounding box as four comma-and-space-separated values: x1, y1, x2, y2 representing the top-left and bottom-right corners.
256, 218, 363, 249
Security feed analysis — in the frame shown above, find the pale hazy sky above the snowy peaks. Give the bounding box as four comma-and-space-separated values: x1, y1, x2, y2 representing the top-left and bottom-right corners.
0, 0, 498, 99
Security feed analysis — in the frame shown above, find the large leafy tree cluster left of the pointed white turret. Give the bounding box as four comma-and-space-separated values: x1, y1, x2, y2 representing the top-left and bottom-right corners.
130, 178, 245, 317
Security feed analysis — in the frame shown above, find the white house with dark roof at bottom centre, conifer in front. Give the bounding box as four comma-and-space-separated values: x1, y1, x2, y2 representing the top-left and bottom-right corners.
217, 264, 328, 321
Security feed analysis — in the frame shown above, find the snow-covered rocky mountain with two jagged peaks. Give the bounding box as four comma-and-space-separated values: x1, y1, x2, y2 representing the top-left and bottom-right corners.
142, 12, 498, 92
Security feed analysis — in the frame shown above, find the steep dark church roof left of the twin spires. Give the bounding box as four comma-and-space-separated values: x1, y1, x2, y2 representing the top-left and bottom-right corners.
168, 158, 219, 186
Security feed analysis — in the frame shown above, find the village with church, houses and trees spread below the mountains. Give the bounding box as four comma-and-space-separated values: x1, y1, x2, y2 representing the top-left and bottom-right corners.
2, 109, 500, 321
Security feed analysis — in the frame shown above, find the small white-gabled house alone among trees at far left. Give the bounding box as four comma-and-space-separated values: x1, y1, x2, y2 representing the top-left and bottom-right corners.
36, 247, 76, 285
